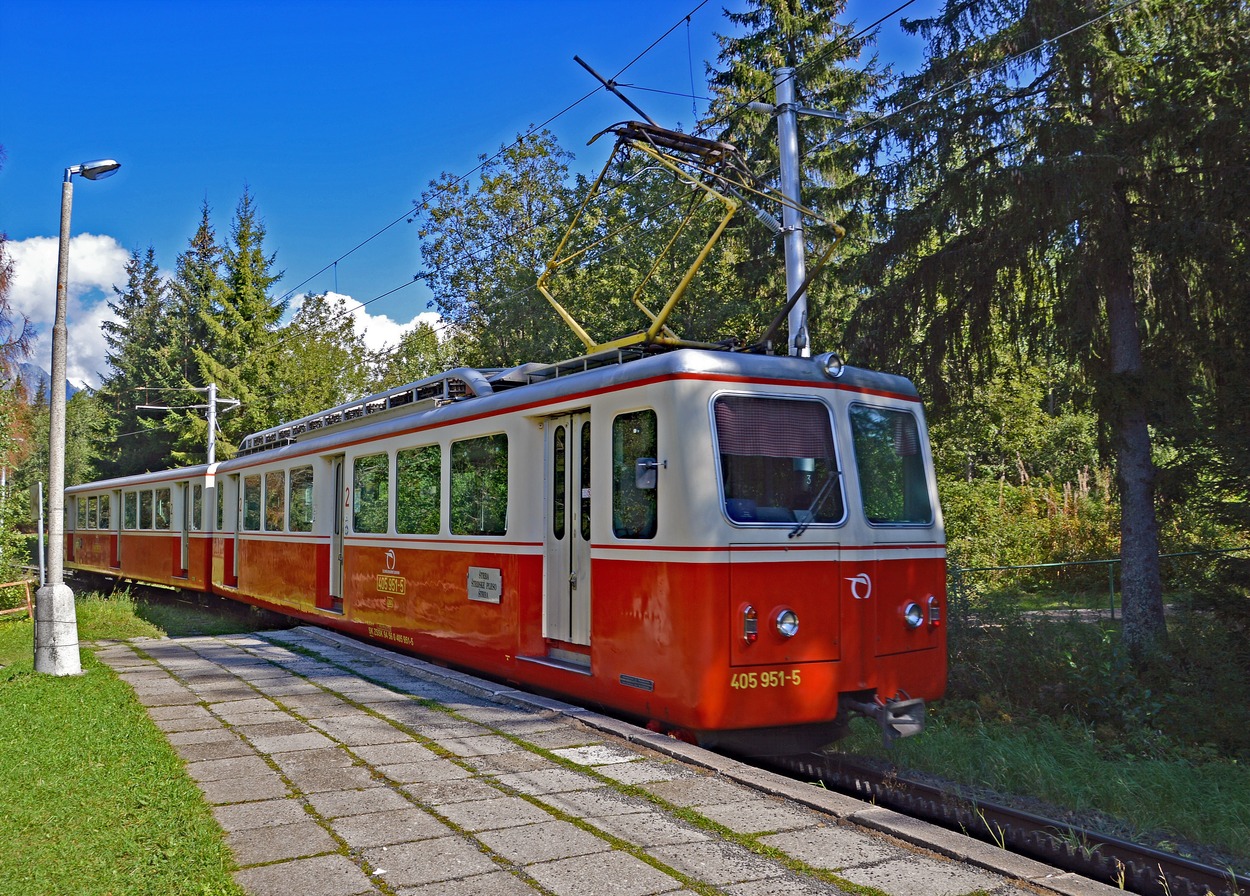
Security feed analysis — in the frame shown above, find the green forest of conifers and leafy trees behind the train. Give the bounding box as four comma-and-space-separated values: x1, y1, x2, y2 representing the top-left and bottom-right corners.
0, 0, 1250, 662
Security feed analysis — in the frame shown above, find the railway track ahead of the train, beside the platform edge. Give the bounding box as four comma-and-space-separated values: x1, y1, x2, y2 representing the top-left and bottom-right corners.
771, 754, 1250, 896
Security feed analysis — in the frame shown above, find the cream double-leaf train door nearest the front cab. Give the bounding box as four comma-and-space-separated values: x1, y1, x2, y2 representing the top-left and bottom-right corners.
543, 411, 591, 646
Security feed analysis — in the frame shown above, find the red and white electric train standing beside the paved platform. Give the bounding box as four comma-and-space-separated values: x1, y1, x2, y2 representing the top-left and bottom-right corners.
66, 349, 946, 754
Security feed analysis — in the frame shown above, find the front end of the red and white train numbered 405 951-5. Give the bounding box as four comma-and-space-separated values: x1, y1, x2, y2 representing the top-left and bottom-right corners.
610, 356, 946, 755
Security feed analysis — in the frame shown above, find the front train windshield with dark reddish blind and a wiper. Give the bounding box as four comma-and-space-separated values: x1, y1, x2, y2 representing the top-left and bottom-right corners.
713, 395, 845, 534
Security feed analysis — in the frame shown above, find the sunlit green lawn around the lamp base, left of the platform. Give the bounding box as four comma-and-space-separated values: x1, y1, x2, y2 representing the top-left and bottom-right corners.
0, 594, 281, 896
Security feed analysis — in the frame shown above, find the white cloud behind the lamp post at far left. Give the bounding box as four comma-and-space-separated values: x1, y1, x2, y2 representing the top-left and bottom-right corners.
6, 234, 130, 386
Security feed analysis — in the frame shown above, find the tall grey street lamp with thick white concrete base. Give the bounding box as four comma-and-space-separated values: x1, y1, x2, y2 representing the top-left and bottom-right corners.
35, 159, 121, 675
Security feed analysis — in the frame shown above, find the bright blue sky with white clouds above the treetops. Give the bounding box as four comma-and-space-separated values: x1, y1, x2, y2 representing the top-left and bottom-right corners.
0, 0, 938, 386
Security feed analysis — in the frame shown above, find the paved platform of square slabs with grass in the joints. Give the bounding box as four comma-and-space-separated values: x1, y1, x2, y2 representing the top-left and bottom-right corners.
98, 627, 1118, 896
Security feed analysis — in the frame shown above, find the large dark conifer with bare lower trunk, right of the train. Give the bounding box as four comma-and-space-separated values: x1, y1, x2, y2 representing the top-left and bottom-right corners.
854, 0, 1248, 657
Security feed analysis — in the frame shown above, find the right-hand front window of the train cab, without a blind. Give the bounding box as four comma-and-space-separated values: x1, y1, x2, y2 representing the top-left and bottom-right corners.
850, 405, 934, 525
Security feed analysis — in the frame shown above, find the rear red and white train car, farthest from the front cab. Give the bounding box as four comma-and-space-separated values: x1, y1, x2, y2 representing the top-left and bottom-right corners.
65, 466, 214, 591
